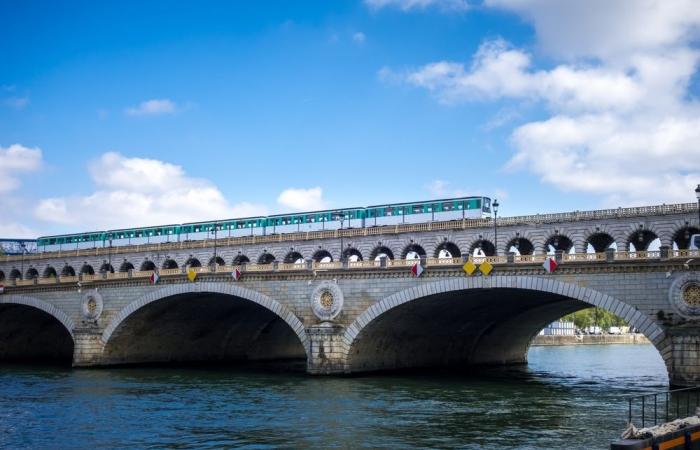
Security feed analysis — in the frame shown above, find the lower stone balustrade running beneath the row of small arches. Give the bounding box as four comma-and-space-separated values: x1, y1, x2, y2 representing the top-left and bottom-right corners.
4, 250, 700, 287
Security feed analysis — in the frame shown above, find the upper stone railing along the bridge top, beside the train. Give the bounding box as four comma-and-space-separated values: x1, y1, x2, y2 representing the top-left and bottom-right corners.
0, 203, 698, 262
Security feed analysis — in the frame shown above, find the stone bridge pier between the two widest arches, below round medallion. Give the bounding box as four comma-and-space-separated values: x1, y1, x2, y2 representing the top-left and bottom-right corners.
306, 322, 347, 375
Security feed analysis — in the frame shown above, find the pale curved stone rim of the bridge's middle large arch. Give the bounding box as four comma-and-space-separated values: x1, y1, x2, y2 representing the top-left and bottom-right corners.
101, 282, 311, 359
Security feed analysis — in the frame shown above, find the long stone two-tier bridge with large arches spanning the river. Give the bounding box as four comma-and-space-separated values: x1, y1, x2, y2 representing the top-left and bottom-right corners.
0, 205, 700, 385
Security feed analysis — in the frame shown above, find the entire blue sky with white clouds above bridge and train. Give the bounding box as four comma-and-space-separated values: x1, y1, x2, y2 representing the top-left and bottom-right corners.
0, 0, 700, 236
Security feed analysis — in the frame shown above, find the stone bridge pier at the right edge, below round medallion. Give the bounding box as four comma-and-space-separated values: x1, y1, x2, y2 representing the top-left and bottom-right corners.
667, 327, 700, 386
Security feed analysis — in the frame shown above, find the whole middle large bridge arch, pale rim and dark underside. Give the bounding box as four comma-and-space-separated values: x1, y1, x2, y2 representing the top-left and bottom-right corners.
101, 282, 310, 364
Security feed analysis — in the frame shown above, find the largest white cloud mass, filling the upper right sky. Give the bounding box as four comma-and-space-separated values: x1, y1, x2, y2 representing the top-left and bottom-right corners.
386, 0, 700, 205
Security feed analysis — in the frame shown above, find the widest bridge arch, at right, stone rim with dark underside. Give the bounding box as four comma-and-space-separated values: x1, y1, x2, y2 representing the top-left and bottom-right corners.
343, 276, 671, 373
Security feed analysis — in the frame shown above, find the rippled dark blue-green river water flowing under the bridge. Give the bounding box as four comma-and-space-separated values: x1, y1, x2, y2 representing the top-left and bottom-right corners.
0, 345, 668, 449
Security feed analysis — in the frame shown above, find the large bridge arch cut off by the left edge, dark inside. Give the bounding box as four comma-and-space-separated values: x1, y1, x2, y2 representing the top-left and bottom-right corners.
0, 294, 75, 364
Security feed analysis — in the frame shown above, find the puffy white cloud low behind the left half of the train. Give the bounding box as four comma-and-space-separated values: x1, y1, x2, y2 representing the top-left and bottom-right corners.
34, 152, 267, 230
